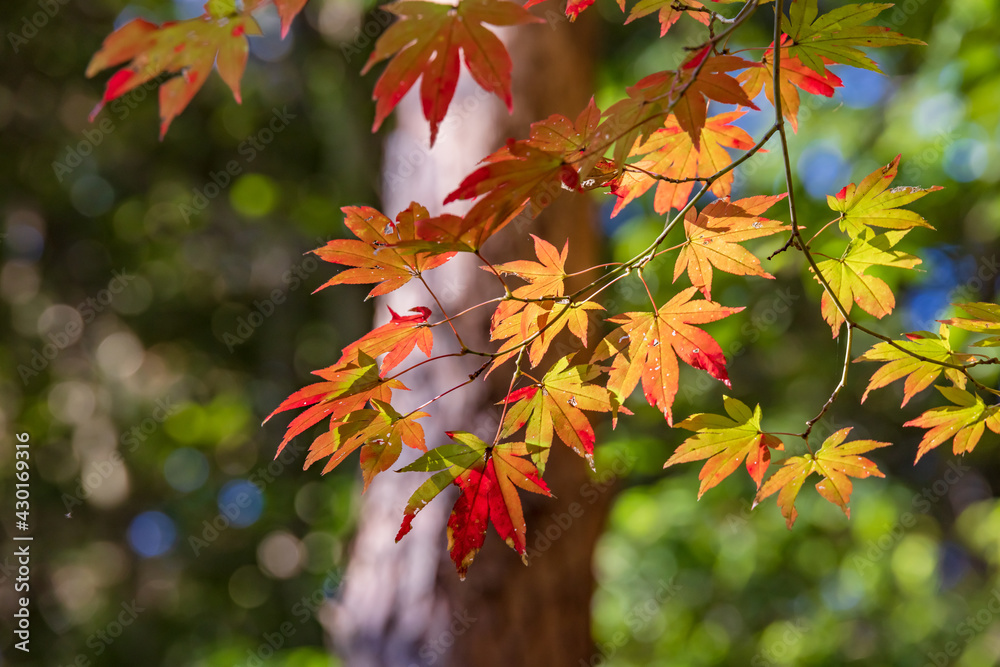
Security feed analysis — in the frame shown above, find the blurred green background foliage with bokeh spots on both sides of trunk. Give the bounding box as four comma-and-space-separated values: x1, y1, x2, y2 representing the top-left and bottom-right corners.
0, 0, 1000, 667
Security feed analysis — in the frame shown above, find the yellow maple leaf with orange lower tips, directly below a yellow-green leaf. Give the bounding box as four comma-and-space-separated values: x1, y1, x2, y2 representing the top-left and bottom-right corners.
817, 229, 921, 338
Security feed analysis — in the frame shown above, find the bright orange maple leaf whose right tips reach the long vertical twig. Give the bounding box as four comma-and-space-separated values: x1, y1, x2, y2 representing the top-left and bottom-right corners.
674, 194, 789, 299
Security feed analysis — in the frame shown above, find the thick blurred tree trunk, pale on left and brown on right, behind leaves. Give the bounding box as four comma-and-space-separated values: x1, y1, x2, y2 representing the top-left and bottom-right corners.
329, 2, 610, 667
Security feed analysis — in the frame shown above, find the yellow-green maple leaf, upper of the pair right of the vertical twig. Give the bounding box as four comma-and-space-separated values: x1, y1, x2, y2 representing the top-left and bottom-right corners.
826, 155, 941, 236
